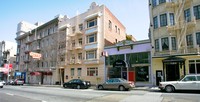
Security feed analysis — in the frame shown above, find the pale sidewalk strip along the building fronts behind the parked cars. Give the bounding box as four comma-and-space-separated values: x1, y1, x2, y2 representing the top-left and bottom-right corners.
24, 84, 160, 91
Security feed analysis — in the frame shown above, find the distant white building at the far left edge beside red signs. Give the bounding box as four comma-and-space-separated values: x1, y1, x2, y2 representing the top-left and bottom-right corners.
0, 41, 17, 81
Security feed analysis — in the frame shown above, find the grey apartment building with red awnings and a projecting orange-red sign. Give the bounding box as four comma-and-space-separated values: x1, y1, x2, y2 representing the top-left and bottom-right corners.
15, 16, 62, 84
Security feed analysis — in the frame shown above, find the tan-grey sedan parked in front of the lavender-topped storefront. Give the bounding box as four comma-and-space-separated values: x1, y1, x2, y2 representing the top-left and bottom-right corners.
97, 78, 135, 91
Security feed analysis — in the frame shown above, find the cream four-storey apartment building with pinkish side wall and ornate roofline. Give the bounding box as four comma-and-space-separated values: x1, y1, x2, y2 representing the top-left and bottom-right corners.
58, 2, 126, 84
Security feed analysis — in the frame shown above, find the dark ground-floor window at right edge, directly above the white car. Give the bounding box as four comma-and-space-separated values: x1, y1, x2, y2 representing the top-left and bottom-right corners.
189, 60, 200, 74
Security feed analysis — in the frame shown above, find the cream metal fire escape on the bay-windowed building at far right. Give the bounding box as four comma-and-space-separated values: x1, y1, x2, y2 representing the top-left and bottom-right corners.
167, 0, 198, 54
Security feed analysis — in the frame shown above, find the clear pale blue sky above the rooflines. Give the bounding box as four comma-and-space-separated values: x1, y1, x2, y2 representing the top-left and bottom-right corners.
0, 0, 149, 42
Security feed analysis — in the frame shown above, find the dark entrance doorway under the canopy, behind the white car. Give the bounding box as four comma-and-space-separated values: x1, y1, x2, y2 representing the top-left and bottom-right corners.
166, 64, 180, 81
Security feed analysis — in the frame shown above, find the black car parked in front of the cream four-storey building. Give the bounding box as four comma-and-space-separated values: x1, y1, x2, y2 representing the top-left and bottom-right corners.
63, 79, 91, 89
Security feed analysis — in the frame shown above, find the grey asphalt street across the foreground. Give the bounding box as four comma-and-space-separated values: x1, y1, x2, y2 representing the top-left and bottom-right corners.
0, 85, 200, 102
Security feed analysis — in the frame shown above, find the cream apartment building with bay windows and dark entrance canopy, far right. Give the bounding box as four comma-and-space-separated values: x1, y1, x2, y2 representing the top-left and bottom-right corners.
149, 0, 200, 85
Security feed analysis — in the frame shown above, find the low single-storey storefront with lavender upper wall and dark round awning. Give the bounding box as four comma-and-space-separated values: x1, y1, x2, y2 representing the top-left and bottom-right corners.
104, 40, 153, 86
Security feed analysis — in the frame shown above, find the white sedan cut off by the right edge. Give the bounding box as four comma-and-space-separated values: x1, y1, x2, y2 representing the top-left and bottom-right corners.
159, 74, 200, 92
